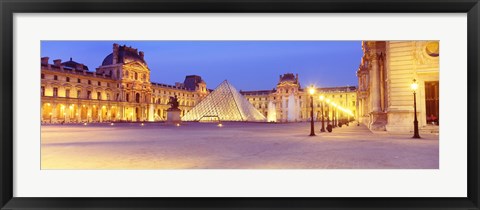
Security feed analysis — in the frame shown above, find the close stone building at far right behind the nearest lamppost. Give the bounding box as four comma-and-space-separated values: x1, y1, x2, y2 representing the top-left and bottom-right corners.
357, 41, 439, 133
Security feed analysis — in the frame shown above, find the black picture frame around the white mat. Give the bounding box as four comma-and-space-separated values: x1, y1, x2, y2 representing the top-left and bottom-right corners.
0, 0, 480, 209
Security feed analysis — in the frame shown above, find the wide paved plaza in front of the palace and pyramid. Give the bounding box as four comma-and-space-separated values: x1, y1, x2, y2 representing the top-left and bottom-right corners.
41, 123, 439, 169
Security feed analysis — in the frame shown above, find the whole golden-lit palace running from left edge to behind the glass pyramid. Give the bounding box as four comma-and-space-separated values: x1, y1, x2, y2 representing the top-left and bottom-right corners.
41, 44, 358, 123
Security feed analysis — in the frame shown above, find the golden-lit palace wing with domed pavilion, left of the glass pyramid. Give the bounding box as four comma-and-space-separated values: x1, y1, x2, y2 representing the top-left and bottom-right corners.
41, 44, 209, 123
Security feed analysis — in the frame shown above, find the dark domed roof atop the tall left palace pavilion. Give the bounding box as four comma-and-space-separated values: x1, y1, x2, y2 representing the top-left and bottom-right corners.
102, 44, 147, 66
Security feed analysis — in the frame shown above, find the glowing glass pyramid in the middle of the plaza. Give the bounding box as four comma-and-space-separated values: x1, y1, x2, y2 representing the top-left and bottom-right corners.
182, 80, 267, 122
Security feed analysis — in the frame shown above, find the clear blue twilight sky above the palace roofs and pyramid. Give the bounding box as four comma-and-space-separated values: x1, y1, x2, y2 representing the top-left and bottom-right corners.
41, 41, 362, 90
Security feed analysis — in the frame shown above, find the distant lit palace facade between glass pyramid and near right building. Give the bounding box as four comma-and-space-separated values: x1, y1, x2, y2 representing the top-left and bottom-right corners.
240, 73, 357, 122
